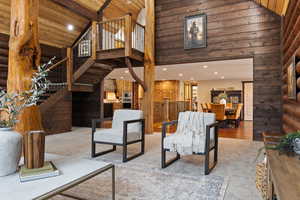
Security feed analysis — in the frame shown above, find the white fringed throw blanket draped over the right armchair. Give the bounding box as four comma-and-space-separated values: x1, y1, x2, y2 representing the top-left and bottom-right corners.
164, 112, 205, 155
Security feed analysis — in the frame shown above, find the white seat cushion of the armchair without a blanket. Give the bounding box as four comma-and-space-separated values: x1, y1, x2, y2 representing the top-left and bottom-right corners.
93, 128, 142, 144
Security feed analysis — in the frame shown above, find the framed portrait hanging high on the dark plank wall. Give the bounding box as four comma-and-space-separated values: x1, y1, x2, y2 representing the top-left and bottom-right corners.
184, 14, 207, 49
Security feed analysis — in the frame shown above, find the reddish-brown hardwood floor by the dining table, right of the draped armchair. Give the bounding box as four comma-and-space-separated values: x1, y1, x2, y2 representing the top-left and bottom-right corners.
219, 121, 253, 140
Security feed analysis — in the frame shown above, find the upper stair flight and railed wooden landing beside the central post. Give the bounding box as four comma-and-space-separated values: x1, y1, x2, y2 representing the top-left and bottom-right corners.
67, 15, 144, 92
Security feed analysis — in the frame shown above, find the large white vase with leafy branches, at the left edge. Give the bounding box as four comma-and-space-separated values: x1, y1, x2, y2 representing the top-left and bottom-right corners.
0, 58, 55, 176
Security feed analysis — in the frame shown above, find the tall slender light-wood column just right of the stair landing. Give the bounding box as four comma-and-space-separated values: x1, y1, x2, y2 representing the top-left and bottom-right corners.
143, 0, 155, 134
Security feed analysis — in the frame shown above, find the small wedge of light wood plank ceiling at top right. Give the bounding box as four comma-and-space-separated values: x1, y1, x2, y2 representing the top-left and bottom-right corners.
255, 0, 289, 16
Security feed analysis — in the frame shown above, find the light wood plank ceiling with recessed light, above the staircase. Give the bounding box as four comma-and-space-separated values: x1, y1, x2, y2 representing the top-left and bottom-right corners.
0, 0, 144, 48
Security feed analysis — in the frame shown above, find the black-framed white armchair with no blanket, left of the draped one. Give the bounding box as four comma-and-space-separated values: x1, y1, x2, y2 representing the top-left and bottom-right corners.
92, 109, 145, 162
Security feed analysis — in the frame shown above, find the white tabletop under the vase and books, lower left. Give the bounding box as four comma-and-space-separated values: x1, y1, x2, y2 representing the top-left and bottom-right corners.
0, 154, 112, 200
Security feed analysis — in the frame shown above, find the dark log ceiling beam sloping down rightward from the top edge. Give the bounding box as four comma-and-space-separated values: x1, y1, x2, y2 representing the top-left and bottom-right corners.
52, 0, 98, 21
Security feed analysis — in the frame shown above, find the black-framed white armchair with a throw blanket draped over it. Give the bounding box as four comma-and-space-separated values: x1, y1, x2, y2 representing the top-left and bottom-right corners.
161, 112, 219, 175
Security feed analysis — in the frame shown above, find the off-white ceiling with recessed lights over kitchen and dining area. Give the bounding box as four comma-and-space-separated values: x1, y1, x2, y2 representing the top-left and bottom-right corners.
106, 59, 253, 81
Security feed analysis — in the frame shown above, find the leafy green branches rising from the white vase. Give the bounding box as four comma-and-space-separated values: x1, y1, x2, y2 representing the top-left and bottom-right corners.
0, 57, 55, 128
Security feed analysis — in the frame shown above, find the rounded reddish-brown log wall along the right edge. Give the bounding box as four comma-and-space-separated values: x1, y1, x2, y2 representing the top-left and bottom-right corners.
282, 0, 300, 133
